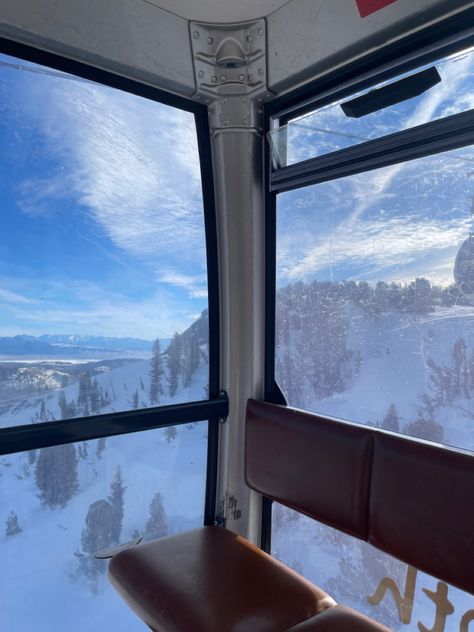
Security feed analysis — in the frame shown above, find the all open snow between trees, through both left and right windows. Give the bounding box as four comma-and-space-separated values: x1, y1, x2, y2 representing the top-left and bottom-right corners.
0, 306, 474, 632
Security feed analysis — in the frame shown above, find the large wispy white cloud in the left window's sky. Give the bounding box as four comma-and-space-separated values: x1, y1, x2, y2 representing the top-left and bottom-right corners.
18, 79, 205, 292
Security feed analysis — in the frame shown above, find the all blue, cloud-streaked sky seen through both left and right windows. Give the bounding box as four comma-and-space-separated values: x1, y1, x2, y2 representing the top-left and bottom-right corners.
0, 46, 474, 339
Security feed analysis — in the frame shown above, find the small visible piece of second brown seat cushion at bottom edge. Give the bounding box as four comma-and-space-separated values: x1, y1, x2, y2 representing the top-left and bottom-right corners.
288, 606, 390, 632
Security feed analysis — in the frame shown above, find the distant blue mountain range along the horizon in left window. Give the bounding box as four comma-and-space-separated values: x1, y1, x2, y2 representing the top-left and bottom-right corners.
0, 334, 170, 358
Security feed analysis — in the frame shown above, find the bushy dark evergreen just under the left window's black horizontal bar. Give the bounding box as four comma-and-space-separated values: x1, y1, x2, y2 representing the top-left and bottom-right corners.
35, 444, 79, 509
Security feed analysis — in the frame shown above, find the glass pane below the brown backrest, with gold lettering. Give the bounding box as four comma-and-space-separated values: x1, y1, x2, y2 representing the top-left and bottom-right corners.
272, 503, 474, 632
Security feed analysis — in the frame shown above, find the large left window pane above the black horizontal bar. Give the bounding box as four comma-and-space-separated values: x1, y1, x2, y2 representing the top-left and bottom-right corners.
0, 55, 208, 427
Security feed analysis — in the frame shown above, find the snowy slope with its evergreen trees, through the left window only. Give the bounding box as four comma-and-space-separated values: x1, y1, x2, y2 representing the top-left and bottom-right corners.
0, 312, 208, 632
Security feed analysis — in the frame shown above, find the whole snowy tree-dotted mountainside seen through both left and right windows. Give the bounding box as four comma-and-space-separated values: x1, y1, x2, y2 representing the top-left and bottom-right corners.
0, 302, 474, 632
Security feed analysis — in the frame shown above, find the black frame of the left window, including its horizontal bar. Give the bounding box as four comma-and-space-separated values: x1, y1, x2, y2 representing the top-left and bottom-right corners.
0, 37, 228, 525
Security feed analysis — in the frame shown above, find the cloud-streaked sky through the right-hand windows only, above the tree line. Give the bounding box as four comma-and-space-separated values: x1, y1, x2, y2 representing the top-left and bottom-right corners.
277, 47, 474, 285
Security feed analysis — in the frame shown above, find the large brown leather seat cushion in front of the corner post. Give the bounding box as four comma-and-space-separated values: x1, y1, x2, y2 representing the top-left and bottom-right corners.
109, 527, 335, 632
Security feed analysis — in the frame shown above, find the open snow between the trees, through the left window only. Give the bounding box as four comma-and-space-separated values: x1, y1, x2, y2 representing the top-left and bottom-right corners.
0, 324, 208, 632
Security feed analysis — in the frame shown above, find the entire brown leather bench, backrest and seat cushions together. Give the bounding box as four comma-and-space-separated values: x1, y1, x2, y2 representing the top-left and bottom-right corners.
109, 400, 474, 632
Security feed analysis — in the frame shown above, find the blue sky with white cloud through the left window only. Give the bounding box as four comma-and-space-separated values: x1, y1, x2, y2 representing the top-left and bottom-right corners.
0, 56, 207, 338
